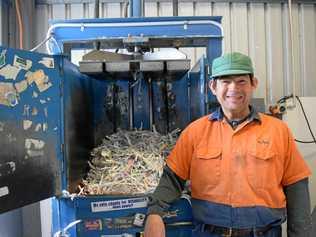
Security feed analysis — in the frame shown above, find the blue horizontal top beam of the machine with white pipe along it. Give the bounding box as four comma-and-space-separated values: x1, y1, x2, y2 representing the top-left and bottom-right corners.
47, 17, 223, 54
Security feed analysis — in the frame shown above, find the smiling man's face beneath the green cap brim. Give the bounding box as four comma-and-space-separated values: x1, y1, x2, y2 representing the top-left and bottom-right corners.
209, 75, 258, 115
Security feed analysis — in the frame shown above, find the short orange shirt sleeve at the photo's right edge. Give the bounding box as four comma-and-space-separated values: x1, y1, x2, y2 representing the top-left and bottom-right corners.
282, 128, 311, 186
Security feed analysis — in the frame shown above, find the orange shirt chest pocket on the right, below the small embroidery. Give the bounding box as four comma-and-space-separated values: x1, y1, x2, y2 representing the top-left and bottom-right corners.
246, 148, 276, 189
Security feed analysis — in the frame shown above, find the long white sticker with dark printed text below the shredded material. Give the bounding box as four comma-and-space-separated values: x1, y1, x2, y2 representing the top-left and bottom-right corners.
91, 197, 148, 212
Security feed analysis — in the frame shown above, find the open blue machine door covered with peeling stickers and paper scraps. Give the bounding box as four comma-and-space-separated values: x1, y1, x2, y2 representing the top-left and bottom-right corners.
0, 47, 63, 212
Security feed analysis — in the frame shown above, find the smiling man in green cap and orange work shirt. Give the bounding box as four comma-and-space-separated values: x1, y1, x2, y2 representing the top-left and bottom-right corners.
145, 53, 311, 237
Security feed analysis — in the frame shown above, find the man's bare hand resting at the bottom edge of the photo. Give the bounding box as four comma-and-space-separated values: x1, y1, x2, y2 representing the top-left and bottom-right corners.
144, 214, 166, 237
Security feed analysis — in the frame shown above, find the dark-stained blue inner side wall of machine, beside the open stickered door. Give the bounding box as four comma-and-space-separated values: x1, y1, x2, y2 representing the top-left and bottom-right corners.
61, 58, 96, 192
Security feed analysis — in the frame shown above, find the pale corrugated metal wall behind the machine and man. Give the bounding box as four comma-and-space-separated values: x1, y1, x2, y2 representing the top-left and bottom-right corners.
14, 0, 316, 104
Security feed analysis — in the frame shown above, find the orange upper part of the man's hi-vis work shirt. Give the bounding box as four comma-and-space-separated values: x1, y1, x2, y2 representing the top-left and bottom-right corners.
166, 110, 311, 208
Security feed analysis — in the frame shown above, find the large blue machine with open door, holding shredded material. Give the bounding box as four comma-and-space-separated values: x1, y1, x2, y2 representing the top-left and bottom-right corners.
0, 17, 223, 237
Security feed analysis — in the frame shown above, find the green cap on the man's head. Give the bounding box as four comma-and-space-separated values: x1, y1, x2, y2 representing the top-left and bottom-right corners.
211, 52, 254, 78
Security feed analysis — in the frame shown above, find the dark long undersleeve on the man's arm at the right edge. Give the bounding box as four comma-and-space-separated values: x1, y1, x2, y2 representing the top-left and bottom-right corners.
284, 178, 312, 237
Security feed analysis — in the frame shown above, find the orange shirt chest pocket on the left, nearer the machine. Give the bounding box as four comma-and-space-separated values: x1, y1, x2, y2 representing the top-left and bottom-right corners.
192, 148, 222, 188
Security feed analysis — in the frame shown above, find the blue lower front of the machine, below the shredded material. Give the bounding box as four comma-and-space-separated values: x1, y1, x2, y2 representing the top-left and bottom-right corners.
54, 196, 193, 237
